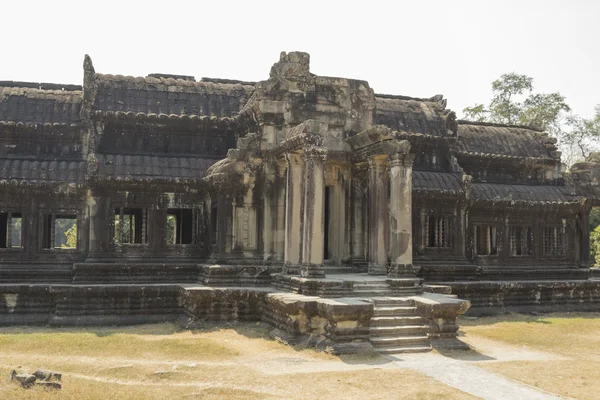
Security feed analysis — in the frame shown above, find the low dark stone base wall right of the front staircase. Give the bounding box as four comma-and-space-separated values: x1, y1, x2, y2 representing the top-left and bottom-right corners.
445, 280, 600, 315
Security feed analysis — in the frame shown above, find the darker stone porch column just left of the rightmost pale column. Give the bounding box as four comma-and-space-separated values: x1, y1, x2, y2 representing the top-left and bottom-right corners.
369, 155, 389, 275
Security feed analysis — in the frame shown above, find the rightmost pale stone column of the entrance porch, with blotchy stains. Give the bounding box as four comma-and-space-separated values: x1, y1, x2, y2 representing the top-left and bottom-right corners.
389, 154, 414, 276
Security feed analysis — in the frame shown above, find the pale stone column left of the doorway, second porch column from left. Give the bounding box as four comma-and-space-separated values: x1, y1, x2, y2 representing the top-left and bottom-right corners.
301, 147, 326, 278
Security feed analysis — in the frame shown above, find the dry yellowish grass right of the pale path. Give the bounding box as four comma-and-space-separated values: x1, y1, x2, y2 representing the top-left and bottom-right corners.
460, 313, 600, 399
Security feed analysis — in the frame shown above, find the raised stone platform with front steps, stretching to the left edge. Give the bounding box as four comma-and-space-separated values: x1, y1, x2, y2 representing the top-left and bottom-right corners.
0, 280, 469, 353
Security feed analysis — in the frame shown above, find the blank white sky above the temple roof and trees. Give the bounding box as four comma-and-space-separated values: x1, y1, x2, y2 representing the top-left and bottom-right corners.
0, 0, 600, 117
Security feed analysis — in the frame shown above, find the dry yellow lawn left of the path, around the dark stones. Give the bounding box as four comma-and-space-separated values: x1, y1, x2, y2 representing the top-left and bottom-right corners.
0, 324, 473, 400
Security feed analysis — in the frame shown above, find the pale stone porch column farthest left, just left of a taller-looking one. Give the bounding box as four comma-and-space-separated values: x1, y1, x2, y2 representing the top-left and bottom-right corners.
284, 153, 305, 274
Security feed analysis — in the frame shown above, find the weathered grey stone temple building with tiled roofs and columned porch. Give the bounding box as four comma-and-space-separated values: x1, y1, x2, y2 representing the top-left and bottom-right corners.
0, 52, 600, 354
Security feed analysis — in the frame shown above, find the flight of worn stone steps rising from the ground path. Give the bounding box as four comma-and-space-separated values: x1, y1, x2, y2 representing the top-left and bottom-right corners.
369, 297, 431, 354
